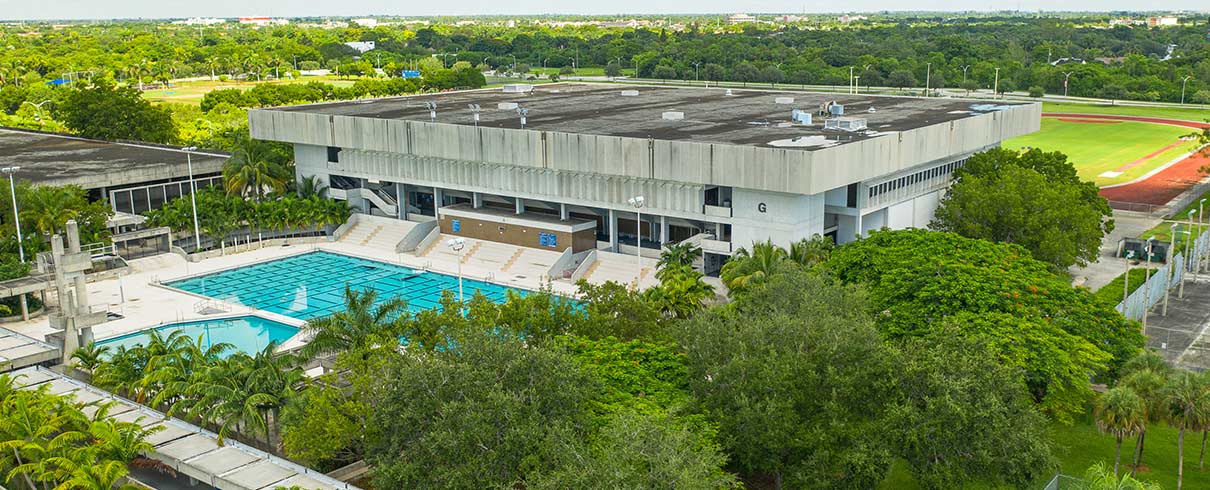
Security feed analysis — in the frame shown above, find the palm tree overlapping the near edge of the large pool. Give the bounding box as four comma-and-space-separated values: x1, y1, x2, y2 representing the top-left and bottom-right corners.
301, 286, 408, 359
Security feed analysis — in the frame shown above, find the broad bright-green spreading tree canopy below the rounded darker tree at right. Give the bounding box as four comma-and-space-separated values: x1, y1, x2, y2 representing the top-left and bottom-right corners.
828, 230, 1143, 420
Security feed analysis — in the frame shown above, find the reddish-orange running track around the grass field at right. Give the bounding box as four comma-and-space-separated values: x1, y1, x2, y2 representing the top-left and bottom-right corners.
1042, 113, 1210, 206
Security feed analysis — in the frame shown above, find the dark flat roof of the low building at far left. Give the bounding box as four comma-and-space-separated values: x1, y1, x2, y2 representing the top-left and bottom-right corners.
0, 128, 227, 189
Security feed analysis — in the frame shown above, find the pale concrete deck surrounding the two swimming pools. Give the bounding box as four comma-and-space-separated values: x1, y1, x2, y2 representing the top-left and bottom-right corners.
5, 237, 605, 350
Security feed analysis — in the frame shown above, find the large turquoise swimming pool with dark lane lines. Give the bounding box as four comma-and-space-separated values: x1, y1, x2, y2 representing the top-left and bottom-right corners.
165, 250, 523, 319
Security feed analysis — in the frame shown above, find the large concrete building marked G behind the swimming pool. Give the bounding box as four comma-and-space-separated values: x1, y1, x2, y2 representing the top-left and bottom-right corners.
249, 83, 1041, 271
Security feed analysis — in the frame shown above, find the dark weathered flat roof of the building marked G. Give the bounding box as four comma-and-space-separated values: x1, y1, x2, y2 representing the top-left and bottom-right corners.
271, 83, 1027, 150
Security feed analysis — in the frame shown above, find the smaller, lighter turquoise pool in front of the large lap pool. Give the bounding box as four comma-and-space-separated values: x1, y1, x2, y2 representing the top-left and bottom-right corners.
97, 316, 299, 354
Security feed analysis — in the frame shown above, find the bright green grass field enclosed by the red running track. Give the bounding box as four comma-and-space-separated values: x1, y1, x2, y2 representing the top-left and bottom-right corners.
1003, 117, 1197, 185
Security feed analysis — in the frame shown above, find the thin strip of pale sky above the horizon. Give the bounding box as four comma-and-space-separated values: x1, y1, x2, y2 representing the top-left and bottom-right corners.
0, 0, 1210, 19
